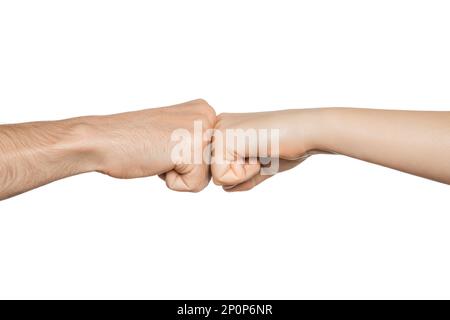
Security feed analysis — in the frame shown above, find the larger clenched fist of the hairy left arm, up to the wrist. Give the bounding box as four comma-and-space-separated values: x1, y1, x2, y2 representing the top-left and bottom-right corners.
91, 99, 215, 192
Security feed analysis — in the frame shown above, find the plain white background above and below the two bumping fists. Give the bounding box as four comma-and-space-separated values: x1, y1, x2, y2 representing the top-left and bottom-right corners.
0, 0, 450, 299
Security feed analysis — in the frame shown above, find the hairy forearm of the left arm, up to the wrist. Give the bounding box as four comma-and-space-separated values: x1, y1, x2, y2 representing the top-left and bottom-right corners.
0, 118, 95, 200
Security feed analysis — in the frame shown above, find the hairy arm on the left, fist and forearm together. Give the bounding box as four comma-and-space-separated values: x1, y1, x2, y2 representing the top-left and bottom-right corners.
0, 100, 215, 200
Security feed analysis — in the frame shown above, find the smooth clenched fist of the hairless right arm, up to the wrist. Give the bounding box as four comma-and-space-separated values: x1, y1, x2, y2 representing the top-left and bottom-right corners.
211, 110, 317, 191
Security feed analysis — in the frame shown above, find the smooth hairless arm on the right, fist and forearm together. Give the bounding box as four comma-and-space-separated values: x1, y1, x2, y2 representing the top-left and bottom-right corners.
211, 108, 450, 191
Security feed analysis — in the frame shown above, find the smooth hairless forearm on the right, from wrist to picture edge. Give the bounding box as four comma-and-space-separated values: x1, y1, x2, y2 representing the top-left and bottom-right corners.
312, 108, 450, 184
